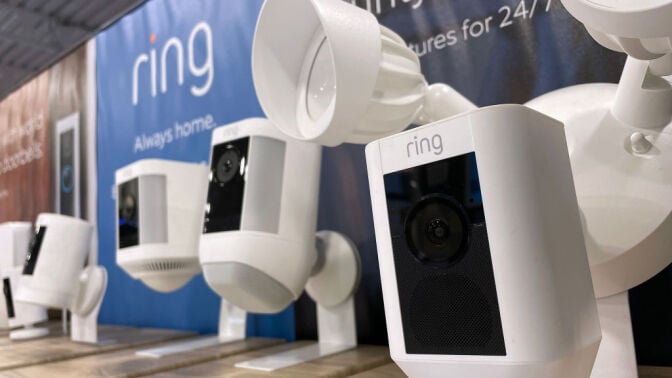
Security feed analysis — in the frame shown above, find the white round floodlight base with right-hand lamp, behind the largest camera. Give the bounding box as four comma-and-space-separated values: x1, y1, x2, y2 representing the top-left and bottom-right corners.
527, 0, 672, 298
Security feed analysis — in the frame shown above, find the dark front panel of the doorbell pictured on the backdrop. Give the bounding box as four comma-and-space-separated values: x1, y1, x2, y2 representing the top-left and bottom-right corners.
58, 129, 77, 216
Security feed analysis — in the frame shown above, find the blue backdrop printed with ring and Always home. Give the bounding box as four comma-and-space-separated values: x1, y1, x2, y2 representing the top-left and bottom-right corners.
96, 0, 294, 339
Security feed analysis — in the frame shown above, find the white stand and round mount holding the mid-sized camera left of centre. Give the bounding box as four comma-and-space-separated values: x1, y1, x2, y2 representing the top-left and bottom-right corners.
235, 231, 361, 372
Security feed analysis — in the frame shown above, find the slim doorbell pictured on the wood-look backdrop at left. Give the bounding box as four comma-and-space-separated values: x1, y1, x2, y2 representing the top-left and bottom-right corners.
55, 113, 81, 218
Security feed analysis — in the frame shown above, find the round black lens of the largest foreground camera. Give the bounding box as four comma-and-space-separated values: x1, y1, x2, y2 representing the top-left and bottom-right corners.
405, 195, 469, 264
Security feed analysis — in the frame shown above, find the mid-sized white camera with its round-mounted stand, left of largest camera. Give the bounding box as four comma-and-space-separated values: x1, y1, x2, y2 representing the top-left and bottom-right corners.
199, 118, 361, 371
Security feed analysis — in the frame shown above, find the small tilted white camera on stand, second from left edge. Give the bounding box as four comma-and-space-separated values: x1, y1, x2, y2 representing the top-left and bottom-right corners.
15, 214, 107, 343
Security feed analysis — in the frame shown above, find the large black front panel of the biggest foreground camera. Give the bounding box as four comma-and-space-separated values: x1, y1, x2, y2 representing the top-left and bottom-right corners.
384, 152, 506, 356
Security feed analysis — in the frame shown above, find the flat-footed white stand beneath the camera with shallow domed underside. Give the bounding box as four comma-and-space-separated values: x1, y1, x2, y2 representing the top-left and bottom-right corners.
135, 299, 247, 358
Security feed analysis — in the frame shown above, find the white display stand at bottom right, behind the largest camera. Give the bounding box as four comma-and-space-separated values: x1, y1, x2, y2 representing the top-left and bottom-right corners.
590, 291, 637, 378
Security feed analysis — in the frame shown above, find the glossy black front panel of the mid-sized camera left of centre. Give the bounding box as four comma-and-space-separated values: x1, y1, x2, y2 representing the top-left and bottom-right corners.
203, 137, 250, 234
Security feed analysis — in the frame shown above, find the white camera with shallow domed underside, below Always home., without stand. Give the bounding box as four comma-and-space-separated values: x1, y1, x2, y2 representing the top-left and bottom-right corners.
115, 159, 208, 292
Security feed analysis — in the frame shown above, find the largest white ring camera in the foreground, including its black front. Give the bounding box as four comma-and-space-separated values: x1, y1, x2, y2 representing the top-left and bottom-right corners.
366, 105, 601, 377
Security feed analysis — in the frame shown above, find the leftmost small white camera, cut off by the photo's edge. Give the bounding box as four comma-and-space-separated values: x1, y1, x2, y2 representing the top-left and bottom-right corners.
0, 222, 48, 337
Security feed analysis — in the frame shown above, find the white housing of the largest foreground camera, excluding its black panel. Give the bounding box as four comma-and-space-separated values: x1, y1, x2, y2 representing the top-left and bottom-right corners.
366, 105, 601, 378
